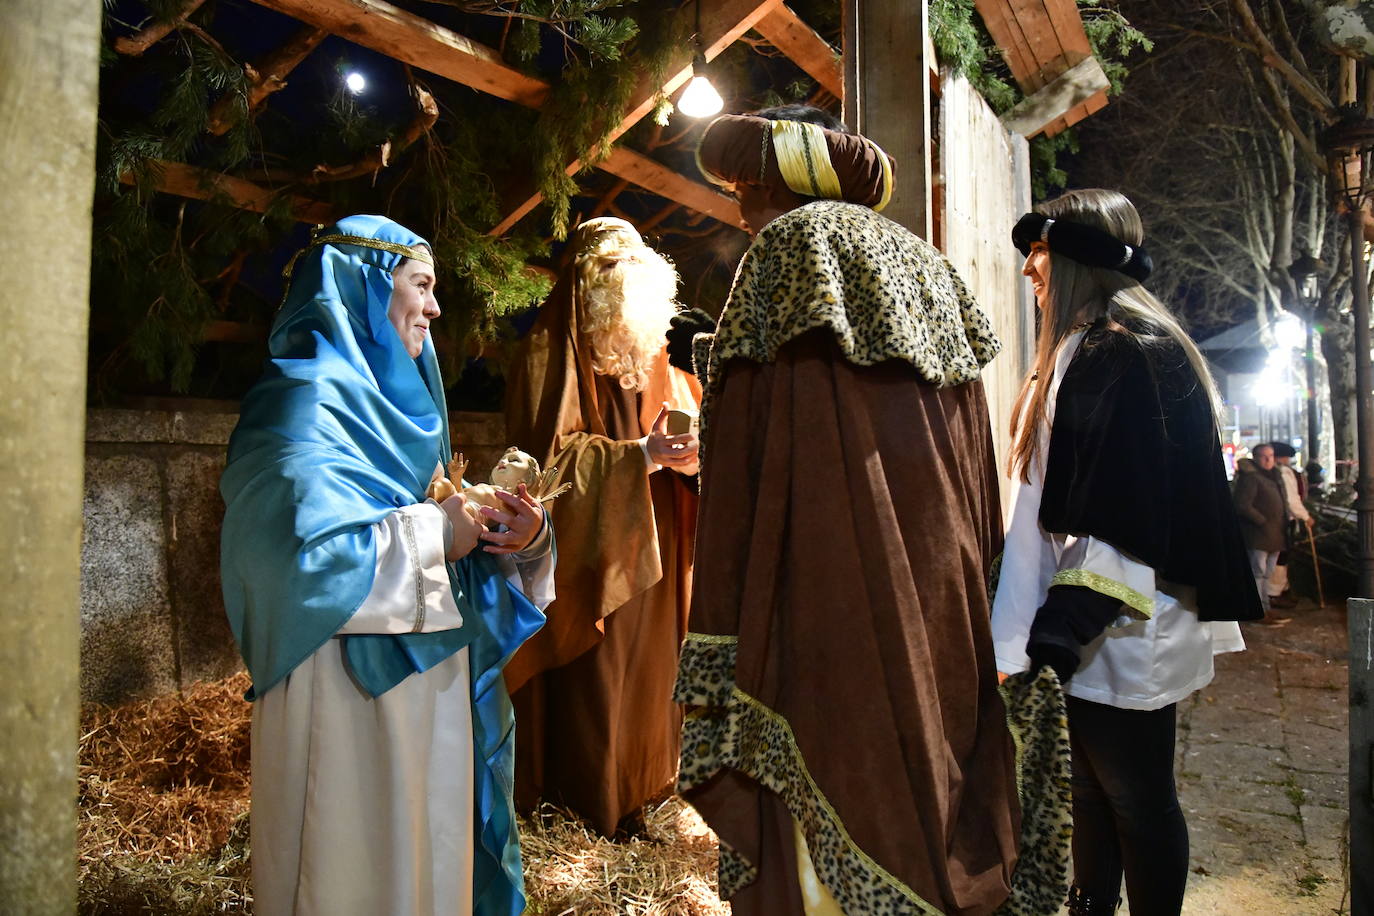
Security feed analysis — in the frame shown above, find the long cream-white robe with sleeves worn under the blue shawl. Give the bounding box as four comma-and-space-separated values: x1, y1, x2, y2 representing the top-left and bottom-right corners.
251, 503, 554, 916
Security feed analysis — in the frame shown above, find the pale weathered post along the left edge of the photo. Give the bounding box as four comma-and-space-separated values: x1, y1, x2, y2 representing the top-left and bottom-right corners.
0, 0, 100, 915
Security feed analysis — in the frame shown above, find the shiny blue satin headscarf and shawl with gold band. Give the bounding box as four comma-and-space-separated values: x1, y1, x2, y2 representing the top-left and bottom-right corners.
220, 216, 544, 913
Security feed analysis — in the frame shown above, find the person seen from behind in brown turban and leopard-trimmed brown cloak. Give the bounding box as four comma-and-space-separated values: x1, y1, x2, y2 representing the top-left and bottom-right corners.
671, 107, 1027, 916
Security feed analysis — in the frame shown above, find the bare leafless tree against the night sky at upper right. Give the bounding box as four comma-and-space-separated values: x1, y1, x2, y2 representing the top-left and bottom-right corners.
1076, 0, 1353, 459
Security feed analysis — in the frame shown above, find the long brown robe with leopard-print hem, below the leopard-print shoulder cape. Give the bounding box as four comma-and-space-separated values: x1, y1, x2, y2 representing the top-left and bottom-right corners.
677, 328, 1020, 916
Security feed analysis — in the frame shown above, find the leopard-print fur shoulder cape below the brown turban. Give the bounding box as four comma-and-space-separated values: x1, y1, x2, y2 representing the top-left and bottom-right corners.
702, 201, 1002, 455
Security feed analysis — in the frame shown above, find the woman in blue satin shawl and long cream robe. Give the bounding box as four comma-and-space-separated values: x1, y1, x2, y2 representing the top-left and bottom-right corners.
220, 216, 554, 916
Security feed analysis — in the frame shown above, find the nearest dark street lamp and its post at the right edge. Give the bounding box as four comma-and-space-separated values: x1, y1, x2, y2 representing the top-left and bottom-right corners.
1322, 106, 1374, 597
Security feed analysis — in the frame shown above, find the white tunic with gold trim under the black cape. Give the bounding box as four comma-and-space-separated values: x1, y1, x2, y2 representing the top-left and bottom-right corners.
992, 331, 1245, 710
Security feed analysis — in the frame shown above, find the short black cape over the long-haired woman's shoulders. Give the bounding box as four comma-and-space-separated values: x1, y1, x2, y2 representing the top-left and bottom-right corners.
1040, 324, 1264, 621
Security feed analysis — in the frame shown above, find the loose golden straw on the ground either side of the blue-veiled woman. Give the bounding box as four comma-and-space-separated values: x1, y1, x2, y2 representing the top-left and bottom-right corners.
77, 673, 730, 916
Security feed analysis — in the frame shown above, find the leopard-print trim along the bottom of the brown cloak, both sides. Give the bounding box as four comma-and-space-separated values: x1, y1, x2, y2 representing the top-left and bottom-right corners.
673, 633, 1072, 916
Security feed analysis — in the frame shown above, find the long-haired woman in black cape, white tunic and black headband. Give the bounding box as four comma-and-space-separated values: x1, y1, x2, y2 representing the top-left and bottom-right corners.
992, 190, 1261, 916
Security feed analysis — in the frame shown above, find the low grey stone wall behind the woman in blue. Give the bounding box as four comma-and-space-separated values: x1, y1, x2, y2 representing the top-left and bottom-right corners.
81, 405, 506, 703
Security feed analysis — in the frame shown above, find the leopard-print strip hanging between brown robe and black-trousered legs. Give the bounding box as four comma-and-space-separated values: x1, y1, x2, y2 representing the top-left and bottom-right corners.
998, 667, 1073, 916
